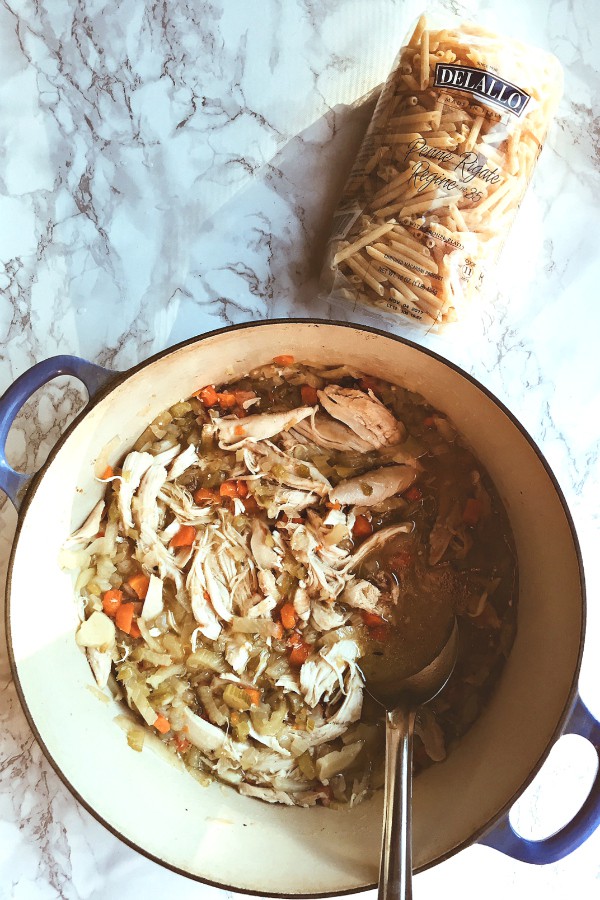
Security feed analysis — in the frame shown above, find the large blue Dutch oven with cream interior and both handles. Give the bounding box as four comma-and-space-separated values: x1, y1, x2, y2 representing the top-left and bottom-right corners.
0, 320, 600, 896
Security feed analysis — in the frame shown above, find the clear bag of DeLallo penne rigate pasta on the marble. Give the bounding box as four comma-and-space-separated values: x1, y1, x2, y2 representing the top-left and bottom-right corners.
322, 16, 562, 331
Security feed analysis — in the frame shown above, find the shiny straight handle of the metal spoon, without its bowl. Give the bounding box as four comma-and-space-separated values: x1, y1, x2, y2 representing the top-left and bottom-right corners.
377, 707, 415, 900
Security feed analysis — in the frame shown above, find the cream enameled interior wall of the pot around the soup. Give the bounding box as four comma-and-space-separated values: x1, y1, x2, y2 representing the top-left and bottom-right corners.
9, 322, 583, 895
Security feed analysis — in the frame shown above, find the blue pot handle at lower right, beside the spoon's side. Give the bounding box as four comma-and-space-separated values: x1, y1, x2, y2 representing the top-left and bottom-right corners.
479, 695, 600, 866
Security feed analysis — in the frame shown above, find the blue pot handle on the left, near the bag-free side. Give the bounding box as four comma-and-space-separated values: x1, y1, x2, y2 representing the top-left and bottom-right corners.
0, 356, 118, 511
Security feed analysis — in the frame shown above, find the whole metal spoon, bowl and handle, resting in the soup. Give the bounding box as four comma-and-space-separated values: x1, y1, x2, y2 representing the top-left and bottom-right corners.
361, 619, 458, 900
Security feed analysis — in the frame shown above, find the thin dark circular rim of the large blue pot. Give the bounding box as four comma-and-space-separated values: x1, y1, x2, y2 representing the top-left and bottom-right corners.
4, 317, 587, 900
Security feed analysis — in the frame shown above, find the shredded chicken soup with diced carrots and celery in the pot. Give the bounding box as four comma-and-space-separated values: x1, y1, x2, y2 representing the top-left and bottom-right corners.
62, 356, 517, 806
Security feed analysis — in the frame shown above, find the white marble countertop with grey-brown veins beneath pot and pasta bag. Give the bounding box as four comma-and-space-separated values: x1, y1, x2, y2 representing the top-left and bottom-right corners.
0, 0, 600, 900
